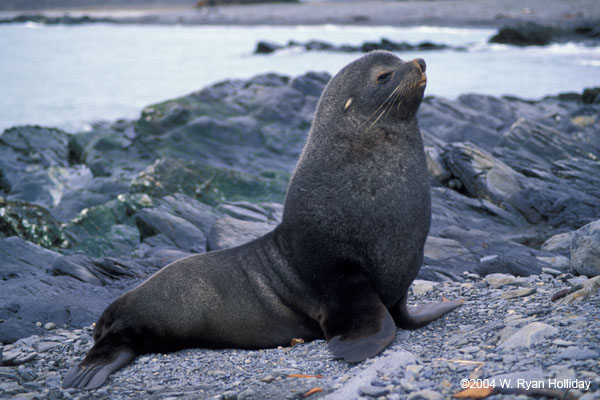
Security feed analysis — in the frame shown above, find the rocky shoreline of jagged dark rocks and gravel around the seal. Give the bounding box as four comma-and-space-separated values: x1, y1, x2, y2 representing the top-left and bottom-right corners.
0, 67, 600, 399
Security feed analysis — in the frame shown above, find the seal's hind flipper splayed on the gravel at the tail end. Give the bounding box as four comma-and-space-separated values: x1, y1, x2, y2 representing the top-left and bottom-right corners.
62, 347, 136, 390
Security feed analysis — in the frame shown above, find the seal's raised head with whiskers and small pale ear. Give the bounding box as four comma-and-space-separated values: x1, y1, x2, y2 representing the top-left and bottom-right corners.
318, 51, 427, 128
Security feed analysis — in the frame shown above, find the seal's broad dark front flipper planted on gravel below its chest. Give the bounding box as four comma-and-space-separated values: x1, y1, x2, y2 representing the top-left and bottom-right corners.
320, 274, 396, 362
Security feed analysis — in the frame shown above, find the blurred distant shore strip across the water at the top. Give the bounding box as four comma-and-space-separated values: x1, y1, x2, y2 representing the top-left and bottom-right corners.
0, 0, 600, 27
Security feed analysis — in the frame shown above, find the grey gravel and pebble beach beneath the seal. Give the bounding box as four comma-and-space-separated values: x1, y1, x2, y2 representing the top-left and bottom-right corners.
0, 273, 600, 400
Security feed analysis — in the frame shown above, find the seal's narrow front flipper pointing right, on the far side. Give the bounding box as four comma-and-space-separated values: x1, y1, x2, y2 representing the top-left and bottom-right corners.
392, 296, 464, 329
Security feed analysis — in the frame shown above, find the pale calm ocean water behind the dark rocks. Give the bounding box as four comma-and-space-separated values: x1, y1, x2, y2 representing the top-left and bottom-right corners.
0, 23, 600, 132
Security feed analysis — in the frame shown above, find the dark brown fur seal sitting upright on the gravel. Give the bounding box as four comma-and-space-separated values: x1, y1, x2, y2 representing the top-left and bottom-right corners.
63, 51, 462, 389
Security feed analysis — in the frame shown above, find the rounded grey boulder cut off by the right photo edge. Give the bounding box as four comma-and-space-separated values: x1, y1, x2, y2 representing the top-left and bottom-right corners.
571, 220, 600, 277
